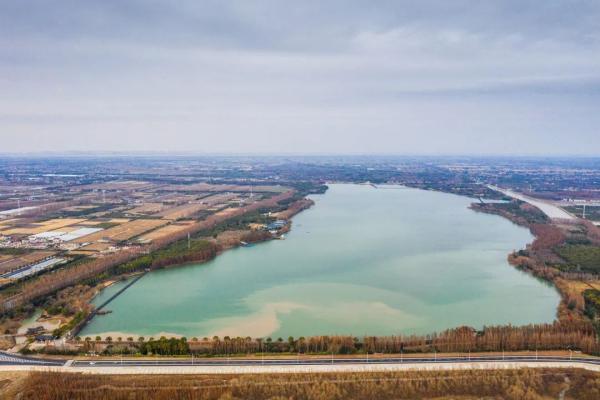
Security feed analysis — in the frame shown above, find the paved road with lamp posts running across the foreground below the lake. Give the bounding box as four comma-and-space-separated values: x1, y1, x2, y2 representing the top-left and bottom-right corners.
0, 352, 600, 371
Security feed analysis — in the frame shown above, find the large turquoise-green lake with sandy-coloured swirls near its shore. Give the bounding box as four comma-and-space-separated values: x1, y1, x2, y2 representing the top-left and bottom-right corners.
80, 184, 559, 338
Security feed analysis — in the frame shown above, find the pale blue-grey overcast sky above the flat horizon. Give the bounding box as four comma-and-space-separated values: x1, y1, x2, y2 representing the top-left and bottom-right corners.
0, 0, 600, 155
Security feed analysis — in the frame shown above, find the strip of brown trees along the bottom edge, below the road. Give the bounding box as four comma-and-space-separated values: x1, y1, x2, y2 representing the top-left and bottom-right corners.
15, 368, 600, 400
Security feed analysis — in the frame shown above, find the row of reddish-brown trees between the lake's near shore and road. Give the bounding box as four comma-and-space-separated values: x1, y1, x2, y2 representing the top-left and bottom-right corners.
79, 320, 600, 356
